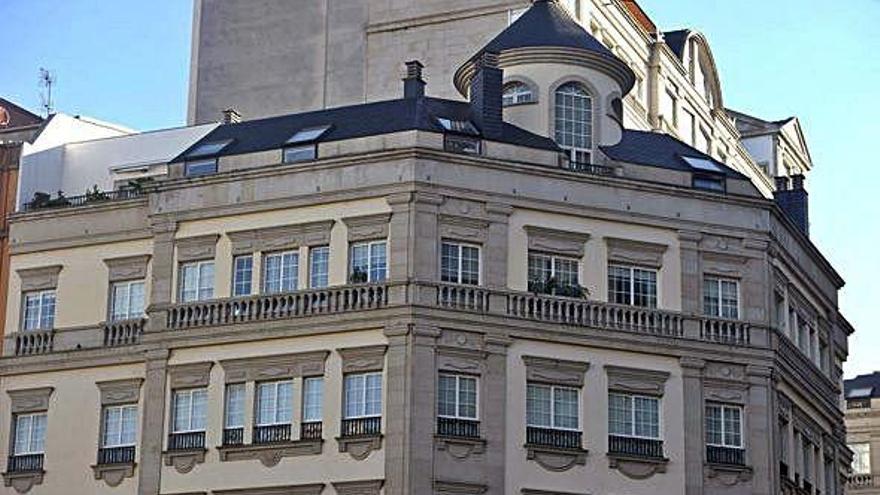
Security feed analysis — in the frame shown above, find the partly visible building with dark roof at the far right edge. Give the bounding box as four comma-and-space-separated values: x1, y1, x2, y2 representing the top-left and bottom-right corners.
844, 371, 880, 495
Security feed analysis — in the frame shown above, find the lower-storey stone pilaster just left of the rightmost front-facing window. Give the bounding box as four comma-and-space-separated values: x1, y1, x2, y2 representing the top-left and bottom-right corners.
680, 356, 706, 495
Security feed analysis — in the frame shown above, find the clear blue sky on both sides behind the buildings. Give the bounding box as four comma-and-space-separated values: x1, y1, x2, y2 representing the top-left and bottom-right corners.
0, 0, 880, 377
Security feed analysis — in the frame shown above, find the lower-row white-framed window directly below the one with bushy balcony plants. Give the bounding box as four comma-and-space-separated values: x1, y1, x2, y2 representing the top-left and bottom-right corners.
526, 383, 579, 430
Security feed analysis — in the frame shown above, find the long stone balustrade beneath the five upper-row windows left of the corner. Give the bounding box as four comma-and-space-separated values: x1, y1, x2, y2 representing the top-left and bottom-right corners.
167, 284, 388, 329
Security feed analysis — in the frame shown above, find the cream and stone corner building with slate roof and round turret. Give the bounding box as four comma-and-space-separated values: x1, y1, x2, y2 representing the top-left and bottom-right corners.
0, 0, 853, 495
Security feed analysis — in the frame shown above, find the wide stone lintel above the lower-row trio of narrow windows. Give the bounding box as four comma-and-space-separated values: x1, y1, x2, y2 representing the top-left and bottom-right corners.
220, 351, 330, 383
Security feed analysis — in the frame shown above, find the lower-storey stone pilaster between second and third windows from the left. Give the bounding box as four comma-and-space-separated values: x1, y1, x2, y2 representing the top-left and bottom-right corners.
137, 349, 169, 495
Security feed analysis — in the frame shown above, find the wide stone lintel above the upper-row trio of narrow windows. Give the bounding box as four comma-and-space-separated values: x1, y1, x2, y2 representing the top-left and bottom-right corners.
226, 220, 335, 254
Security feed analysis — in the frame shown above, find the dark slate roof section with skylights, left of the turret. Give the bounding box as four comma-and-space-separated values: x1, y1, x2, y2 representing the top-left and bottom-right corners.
172, 97, 559, 163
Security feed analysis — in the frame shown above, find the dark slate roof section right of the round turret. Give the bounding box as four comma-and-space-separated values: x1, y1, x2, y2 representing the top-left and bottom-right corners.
601, 129, 748, 180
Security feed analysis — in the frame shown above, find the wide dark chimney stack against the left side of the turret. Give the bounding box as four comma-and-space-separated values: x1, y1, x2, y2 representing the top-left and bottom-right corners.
470, 52, 504, 139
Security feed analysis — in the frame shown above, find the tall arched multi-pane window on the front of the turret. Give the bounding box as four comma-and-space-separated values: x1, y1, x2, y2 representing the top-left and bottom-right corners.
554, 83, 593, 164
